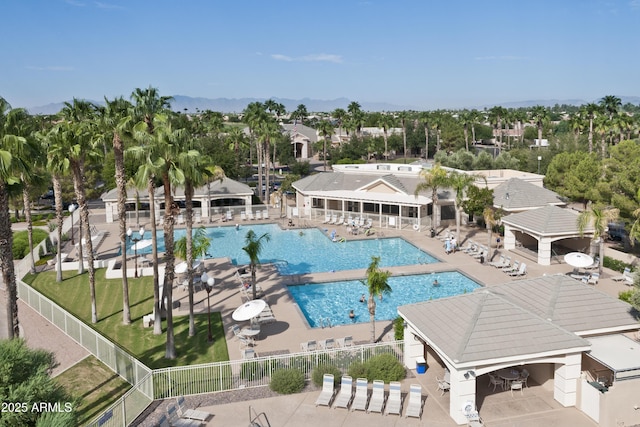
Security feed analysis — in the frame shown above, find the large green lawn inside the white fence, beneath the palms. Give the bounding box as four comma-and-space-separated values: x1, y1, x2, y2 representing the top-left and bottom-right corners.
24, 269, 229, 369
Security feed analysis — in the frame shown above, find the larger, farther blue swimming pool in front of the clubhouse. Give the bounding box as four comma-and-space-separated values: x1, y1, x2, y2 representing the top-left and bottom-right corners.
128, 224, 438, 275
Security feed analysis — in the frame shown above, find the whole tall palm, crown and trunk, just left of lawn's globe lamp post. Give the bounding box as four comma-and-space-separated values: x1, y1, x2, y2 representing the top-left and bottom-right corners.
100, 97, 137, 325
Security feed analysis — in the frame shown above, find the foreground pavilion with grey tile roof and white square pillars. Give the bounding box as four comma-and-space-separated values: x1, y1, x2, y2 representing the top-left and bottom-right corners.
398, 275, 640, 424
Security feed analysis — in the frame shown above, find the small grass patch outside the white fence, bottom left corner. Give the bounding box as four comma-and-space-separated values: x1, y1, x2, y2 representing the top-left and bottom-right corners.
55, 356, 131, 425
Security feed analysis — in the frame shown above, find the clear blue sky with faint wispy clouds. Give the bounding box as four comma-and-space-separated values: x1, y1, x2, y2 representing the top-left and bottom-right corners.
0, 0, 640, 109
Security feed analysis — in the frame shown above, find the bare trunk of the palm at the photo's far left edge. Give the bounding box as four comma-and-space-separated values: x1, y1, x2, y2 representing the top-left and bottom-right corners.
0, 180, 20, 339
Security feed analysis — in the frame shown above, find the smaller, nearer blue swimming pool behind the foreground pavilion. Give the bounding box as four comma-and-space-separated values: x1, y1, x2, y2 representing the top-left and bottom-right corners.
288, 271, 481, 328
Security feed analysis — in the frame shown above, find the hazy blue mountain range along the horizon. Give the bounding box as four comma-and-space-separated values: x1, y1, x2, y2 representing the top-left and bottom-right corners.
27, 95, 640, 114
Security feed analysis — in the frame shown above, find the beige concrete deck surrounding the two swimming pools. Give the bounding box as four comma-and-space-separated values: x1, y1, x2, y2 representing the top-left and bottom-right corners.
20, 210, 628, 427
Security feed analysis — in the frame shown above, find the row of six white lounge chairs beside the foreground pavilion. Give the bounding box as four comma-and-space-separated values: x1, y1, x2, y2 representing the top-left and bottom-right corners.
316, 374, 423, 418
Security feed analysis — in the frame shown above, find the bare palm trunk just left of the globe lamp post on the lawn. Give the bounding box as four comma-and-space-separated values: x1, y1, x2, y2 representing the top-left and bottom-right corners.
113, 133, 130, 325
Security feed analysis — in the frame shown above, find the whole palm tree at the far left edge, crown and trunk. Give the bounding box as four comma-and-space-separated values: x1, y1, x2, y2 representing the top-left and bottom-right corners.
0, 97, 27, 338
